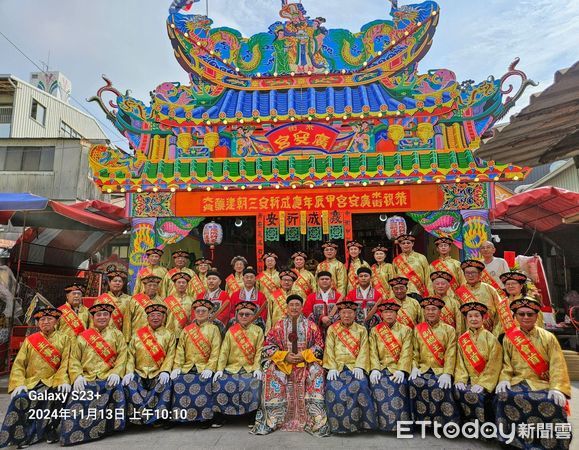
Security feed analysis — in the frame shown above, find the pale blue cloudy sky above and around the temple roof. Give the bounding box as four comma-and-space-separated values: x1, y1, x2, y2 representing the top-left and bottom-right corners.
0, 0, 579, 147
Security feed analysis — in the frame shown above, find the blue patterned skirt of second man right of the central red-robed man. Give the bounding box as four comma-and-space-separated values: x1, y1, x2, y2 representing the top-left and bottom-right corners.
370, 369, 412, 431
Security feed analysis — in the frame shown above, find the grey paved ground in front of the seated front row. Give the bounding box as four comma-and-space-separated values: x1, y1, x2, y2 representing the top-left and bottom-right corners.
0, 380, 579, 450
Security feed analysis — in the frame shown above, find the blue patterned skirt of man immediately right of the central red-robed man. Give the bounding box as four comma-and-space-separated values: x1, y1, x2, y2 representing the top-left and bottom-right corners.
326, 369, 376, 433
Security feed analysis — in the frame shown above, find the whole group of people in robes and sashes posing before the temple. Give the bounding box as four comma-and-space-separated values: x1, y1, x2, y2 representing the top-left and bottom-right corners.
0, 235, 570, 448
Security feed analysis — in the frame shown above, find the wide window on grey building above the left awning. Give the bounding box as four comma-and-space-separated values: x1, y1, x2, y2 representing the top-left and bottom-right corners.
0, 147, 54, 172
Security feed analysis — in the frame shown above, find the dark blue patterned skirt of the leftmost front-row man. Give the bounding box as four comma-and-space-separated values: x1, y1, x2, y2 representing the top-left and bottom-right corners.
0, 384, 64, 448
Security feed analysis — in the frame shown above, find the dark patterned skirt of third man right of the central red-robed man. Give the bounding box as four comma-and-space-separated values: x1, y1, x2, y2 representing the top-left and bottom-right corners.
408, 371, 460, 425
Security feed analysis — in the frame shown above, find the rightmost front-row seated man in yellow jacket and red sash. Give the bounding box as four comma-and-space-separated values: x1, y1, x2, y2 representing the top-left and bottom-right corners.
494, 297, 571, 449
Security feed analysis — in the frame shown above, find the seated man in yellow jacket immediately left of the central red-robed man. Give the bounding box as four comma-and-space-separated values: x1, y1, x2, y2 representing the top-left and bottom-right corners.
212, 302, 263, 428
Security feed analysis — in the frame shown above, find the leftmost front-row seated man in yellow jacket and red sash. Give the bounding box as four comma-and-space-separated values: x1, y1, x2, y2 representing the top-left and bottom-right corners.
0, 307, 70, 448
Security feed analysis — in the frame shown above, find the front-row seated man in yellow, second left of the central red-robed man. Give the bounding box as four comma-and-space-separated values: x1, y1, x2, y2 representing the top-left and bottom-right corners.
171, 299, 221, 426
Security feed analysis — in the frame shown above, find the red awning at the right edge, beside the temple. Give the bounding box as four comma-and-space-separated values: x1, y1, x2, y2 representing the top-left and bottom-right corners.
491, 186, 579, 233
